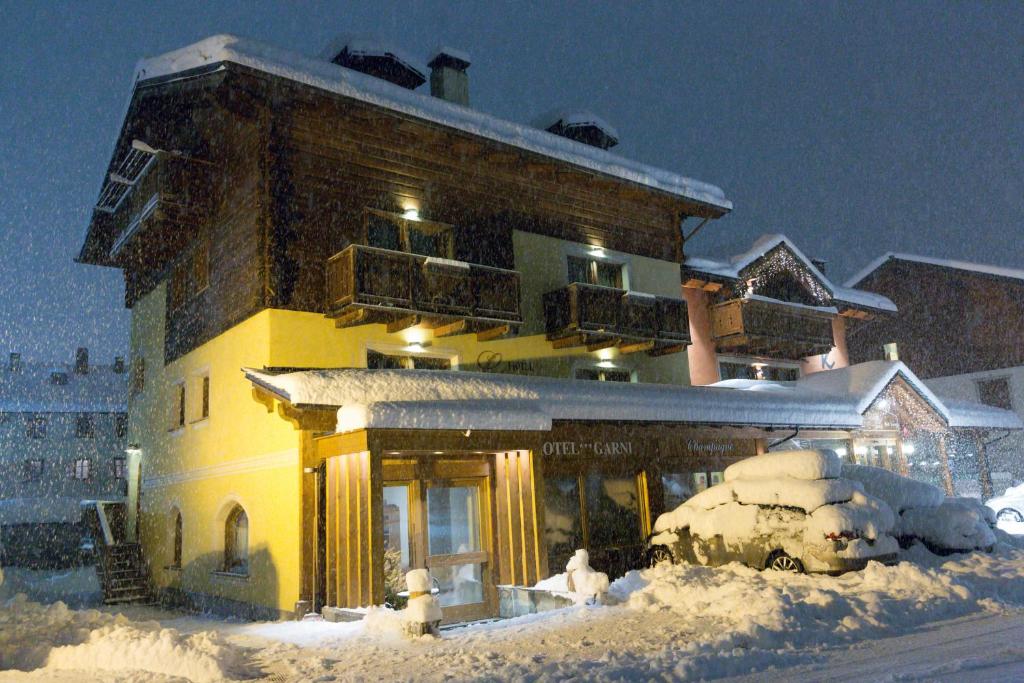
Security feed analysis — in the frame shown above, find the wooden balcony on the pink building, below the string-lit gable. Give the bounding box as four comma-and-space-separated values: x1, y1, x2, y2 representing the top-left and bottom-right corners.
711, 299, 834, 360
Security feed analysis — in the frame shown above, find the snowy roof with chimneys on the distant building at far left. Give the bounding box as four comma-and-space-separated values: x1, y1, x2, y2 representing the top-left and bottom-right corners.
0, 362, 128, 413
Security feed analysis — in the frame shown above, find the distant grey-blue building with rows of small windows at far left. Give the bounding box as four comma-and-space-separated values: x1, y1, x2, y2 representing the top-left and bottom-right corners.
0, 348, 128, 566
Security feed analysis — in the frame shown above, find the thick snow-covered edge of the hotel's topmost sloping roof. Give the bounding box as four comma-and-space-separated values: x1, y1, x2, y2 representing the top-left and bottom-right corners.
135, 35, 732, 212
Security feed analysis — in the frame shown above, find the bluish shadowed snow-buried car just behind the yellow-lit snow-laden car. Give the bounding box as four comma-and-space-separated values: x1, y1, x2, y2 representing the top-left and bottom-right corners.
843, 463, 995, 554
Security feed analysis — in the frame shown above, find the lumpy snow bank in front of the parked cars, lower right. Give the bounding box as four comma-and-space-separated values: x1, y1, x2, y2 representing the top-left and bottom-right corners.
608, 546, 1024, 679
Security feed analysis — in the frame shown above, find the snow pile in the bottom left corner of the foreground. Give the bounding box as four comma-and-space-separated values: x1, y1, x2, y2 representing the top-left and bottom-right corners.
0, 594, 241, 683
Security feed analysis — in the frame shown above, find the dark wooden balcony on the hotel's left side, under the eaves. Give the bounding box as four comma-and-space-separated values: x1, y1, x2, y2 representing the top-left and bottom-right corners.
96, 148, 210, 262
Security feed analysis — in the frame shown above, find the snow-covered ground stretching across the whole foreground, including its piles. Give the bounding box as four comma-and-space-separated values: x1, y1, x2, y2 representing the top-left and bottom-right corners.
0, 537, 1024, 681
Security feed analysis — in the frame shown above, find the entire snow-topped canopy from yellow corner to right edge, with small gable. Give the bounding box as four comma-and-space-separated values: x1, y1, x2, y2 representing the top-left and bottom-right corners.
243, 361, 1024, 432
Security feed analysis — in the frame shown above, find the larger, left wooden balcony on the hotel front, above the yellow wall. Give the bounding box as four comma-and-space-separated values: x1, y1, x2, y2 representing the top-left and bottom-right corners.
327, 245, 522, 339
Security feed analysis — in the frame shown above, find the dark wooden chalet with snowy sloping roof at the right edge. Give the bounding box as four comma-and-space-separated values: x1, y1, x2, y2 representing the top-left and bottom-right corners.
847, 253, 1024, 498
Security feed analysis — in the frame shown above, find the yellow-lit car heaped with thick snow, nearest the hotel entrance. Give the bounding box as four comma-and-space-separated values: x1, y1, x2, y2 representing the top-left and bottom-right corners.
647, 451, 899, 573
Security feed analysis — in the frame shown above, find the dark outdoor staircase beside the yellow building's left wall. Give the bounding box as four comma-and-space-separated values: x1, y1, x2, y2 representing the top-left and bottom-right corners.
82, 501, 153, 605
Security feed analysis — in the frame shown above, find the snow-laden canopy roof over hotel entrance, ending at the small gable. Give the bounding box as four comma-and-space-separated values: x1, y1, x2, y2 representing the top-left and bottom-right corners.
243, 368, 861, 431
